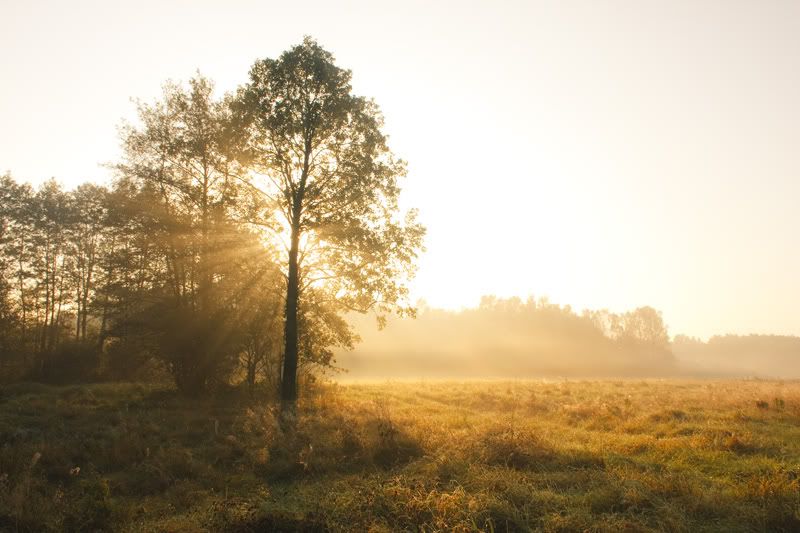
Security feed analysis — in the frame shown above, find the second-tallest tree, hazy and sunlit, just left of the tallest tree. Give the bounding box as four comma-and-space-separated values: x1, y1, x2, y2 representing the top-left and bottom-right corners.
117, 76, 245, 393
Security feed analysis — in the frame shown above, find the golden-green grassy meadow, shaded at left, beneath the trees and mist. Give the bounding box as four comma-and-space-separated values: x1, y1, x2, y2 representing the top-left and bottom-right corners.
0, 381, 800, 532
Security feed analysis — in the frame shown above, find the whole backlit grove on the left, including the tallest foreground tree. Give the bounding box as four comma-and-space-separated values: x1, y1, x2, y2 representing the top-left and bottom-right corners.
0, 38, 424, 407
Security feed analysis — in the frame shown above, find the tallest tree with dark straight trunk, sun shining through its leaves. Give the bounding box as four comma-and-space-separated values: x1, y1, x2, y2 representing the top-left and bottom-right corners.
234, 38, 424, 419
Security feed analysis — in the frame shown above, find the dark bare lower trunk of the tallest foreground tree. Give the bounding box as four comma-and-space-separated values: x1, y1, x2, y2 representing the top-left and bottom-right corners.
281, 224, 300, 421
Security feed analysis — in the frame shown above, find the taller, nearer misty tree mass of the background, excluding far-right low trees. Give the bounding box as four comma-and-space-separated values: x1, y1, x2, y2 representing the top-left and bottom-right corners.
339, 297, 678, 379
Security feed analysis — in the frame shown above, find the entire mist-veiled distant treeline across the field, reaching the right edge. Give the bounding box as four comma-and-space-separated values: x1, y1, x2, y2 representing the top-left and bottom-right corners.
338, 297, 800, 379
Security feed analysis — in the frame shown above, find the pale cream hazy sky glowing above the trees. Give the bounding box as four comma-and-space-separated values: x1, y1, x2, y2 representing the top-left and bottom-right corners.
0, 0, 800, 337
